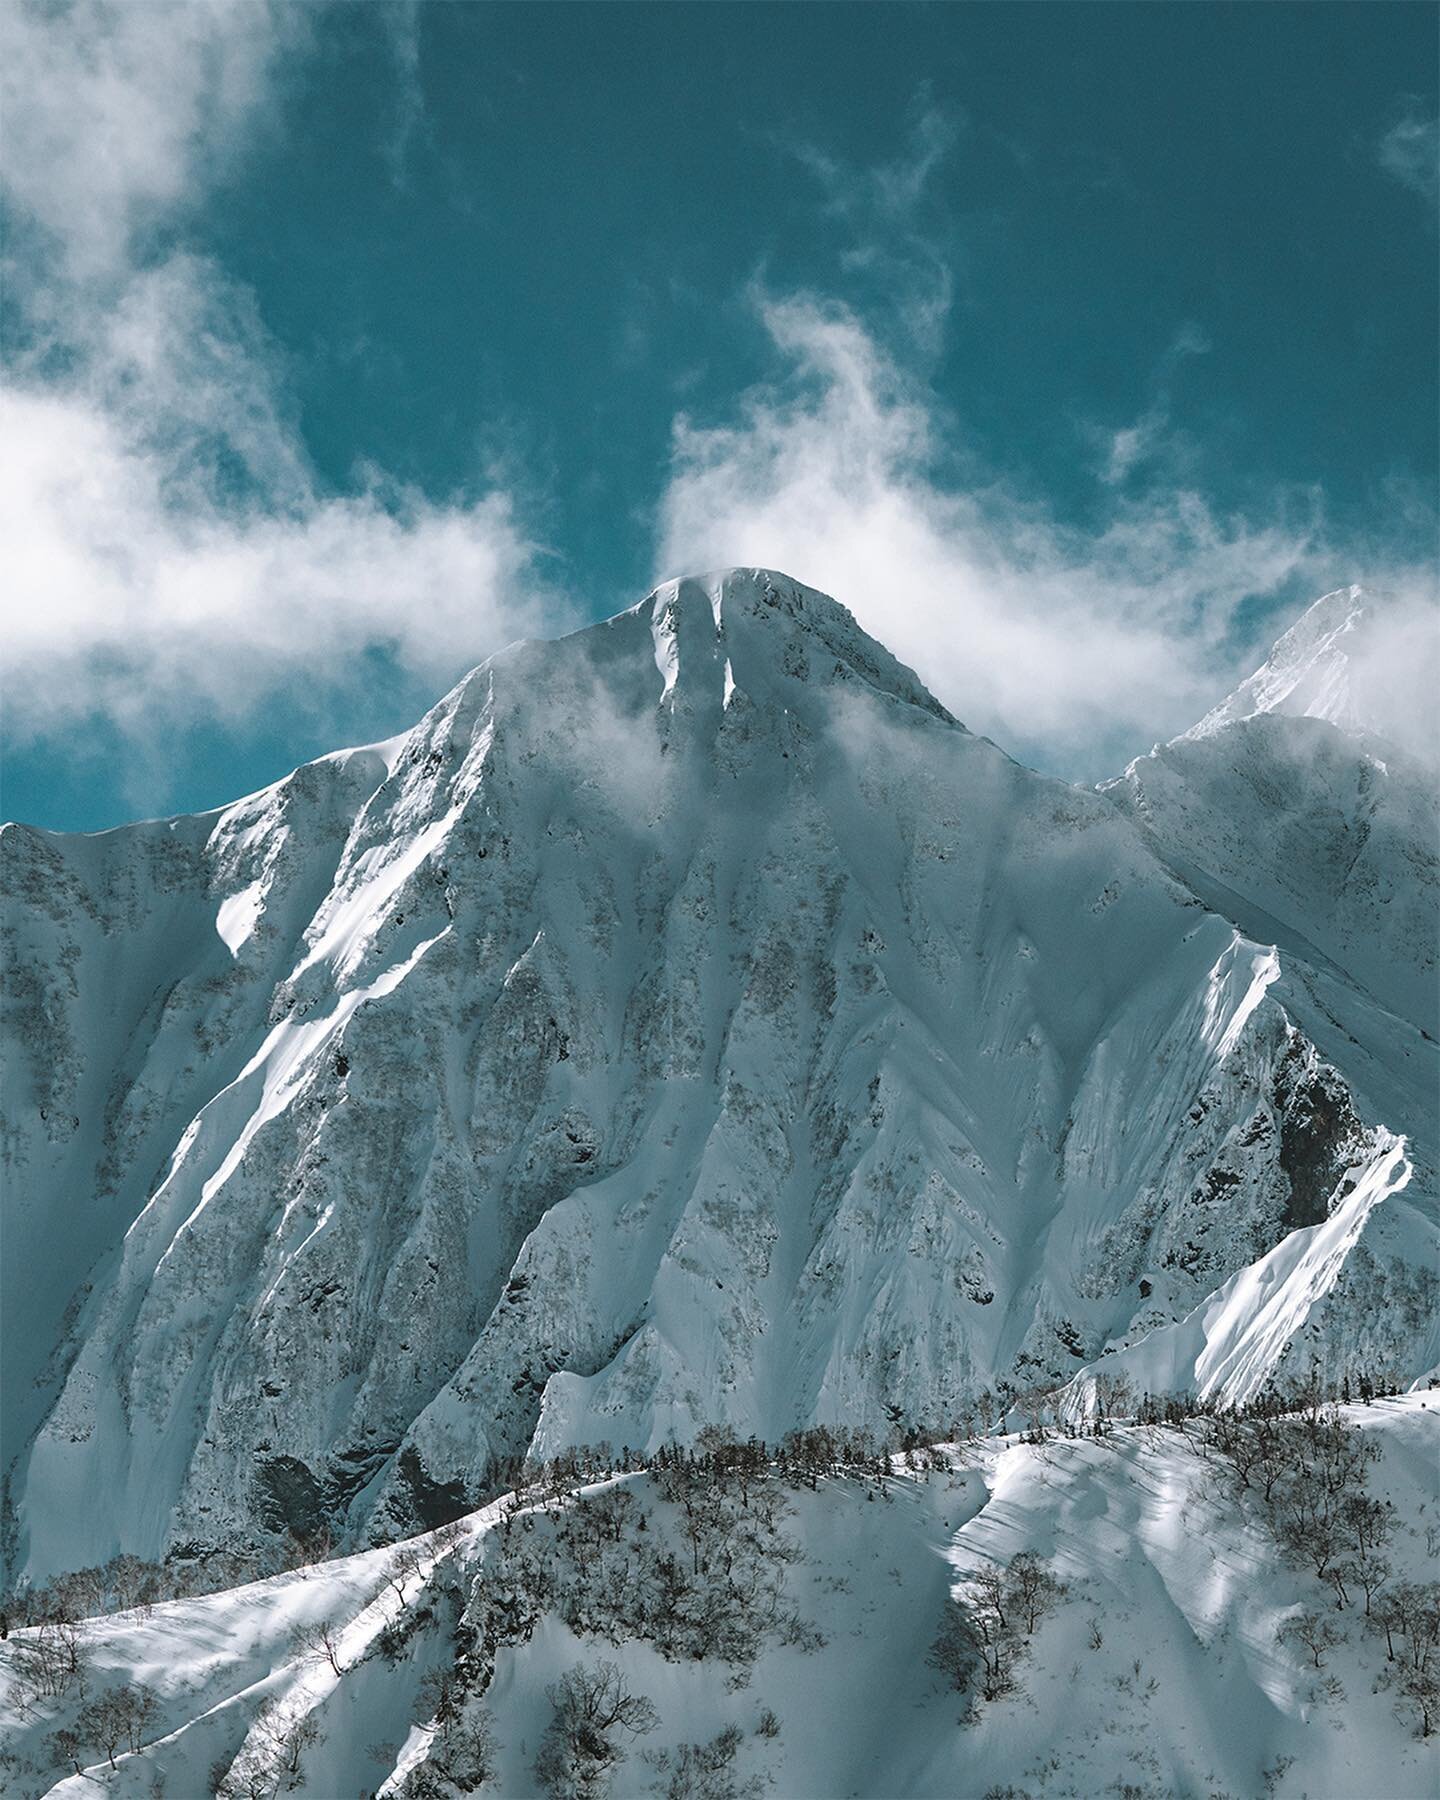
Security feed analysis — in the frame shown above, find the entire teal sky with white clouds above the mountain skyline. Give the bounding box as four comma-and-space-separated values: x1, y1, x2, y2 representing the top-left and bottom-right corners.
4, 0, 1440, 830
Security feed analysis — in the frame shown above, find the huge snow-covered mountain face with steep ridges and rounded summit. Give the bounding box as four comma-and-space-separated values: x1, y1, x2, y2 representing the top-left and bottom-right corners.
0, 571, 1440, 1573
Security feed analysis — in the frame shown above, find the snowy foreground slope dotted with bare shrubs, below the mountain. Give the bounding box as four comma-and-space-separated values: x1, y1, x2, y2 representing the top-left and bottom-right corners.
0, 1395, 1440, 1800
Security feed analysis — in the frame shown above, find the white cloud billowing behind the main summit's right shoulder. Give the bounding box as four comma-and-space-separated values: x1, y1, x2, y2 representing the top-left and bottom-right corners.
657, 297, 1336, 776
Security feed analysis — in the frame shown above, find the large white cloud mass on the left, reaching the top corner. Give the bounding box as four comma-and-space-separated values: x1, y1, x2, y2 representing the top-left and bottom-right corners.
0, 0, 540, 766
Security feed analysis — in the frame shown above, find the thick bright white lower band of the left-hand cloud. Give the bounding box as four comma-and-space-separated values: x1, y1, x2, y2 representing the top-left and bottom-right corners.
0, 376, 531, 738
